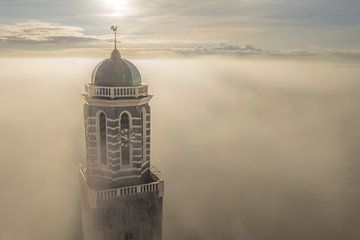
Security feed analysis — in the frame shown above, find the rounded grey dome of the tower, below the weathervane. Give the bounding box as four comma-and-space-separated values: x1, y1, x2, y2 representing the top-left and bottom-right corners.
91, 49, 141, 87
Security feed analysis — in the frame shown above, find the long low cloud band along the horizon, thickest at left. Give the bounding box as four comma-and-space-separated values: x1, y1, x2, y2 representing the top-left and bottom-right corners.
0, 21, 360, 59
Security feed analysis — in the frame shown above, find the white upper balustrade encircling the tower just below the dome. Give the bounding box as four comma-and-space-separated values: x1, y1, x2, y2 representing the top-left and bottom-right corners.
85, 84, 148, 99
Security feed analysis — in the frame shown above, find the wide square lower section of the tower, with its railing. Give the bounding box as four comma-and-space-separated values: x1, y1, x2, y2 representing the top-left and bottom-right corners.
80, 165, 164, 240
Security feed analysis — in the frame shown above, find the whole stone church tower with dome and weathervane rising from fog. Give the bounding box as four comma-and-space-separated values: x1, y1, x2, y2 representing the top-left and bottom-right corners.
80, 27, 164, 240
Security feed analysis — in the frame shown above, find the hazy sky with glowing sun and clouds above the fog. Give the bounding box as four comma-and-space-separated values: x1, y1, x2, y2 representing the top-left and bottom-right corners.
0, 0, 360, 59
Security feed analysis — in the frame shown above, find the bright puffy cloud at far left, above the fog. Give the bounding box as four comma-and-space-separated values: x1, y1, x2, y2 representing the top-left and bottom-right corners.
0, 21, 100, 44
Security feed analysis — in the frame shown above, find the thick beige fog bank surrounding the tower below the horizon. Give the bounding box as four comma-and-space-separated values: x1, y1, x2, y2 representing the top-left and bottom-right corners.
0, 57, 360, 240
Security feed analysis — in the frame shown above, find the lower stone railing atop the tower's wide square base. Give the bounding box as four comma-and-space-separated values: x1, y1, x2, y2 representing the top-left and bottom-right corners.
96, 181, 164, 199
